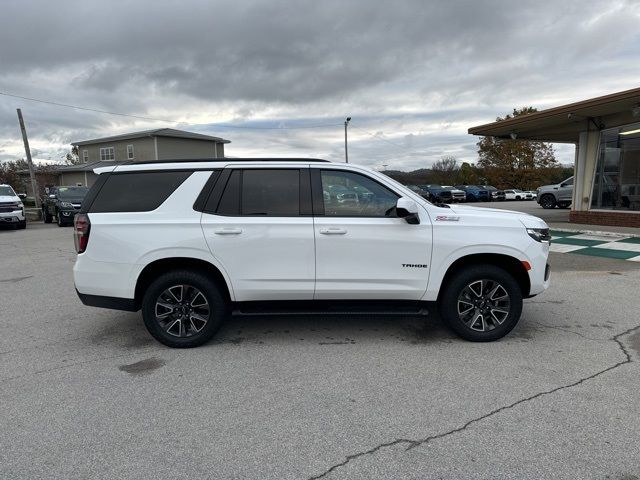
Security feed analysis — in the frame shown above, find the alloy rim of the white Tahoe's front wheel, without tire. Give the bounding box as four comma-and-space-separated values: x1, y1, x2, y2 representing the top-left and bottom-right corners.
458, 279, 511, 332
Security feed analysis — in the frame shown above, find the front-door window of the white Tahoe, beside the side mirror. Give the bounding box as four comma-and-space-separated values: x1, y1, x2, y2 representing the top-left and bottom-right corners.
320, 170, 399, 217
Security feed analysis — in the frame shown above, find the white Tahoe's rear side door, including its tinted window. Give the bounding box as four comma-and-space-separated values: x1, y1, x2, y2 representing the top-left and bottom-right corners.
202, 166, 315, 301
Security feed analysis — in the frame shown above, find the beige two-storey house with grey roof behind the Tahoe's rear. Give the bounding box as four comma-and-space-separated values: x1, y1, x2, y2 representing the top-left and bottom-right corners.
56, 128, 230, 186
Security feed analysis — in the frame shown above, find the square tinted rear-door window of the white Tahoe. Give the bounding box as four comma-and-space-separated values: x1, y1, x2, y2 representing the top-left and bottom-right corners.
240, 169, 300, 217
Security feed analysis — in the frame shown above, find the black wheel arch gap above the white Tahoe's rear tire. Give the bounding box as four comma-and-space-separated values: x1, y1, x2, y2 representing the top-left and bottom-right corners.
134, 257, 232, 309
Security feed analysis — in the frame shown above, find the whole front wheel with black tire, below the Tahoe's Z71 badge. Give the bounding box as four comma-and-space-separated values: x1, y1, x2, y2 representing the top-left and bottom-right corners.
438, 265, 522, 342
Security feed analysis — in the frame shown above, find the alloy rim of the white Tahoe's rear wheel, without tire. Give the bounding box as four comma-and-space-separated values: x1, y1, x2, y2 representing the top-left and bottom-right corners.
154, 284, 211, 337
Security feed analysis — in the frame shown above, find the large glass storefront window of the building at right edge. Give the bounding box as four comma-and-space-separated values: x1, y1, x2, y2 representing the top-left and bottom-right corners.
591, 123, 640, 211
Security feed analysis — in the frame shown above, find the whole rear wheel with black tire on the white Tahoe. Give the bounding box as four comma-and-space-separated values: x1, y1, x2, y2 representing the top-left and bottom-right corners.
142, 270, 228, 348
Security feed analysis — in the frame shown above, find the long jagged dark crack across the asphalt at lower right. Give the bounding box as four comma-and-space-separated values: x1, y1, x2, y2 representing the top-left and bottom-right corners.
309, 325, 640, 480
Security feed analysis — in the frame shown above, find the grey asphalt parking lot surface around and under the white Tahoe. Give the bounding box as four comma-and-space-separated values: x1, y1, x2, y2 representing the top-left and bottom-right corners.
0, 223, 640, 479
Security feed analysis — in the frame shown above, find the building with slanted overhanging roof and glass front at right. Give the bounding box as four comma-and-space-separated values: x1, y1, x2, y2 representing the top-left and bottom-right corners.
469, 88, 640, 227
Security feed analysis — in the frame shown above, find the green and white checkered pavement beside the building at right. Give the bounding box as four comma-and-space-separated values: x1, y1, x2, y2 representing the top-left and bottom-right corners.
551, 230, 640, 262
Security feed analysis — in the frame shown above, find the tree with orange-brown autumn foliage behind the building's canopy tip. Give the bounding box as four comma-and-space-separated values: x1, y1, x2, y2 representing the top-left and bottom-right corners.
477, 107, 560, 190
